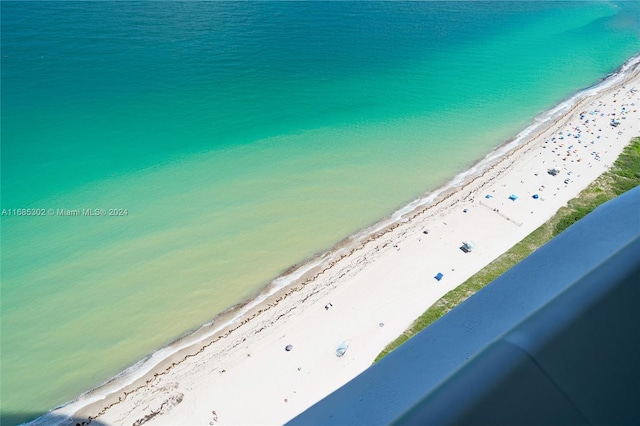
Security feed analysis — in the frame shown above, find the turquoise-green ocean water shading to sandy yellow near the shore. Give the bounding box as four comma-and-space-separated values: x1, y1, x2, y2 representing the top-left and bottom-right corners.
0, 1, 640, 424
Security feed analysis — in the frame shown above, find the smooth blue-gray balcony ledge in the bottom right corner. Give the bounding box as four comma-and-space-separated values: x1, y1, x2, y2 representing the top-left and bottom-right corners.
289, 187, 640, 425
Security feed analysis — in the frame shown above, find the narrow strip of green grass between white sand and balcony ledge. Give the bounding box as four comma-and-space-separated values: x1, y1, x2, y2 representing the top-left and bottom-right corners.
374, 137, 640, 363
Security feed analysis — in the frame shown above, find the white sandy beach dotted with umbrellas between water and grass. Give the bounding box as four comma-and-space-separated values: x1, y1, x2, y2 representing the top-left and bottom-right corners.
58, 57, 640, 425
